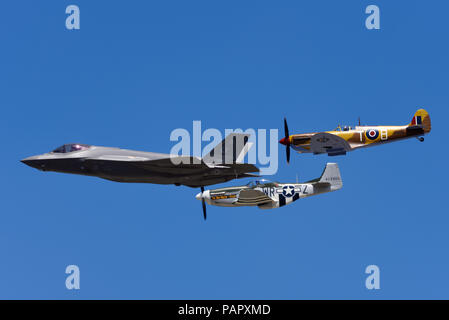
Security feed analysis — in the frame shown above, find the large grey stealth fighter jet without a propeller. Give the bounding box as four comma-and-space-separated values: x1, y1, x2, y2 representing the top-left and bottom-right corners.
21, 133, 259, 190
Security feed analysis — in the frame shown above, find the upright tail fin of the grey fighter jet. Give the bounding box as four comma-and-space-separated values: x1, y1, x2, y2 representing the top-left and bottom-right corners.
203, 133, 253, 164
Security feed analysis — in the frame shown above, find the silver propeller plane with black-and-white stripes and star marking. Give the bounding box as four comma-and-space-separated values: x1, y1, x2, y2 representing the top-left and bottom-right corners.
196, 163, 343, 215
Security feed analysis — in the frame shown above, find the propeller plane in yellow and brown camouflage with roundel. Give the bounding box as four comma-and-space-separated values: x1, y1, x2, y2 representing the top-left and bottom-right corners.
279, 109, 431, 163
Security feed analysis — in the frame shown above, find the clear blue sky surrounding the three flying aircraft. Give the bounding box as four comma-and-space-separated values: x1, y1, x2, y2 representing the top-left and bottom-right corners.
0, 0, 449, 299
